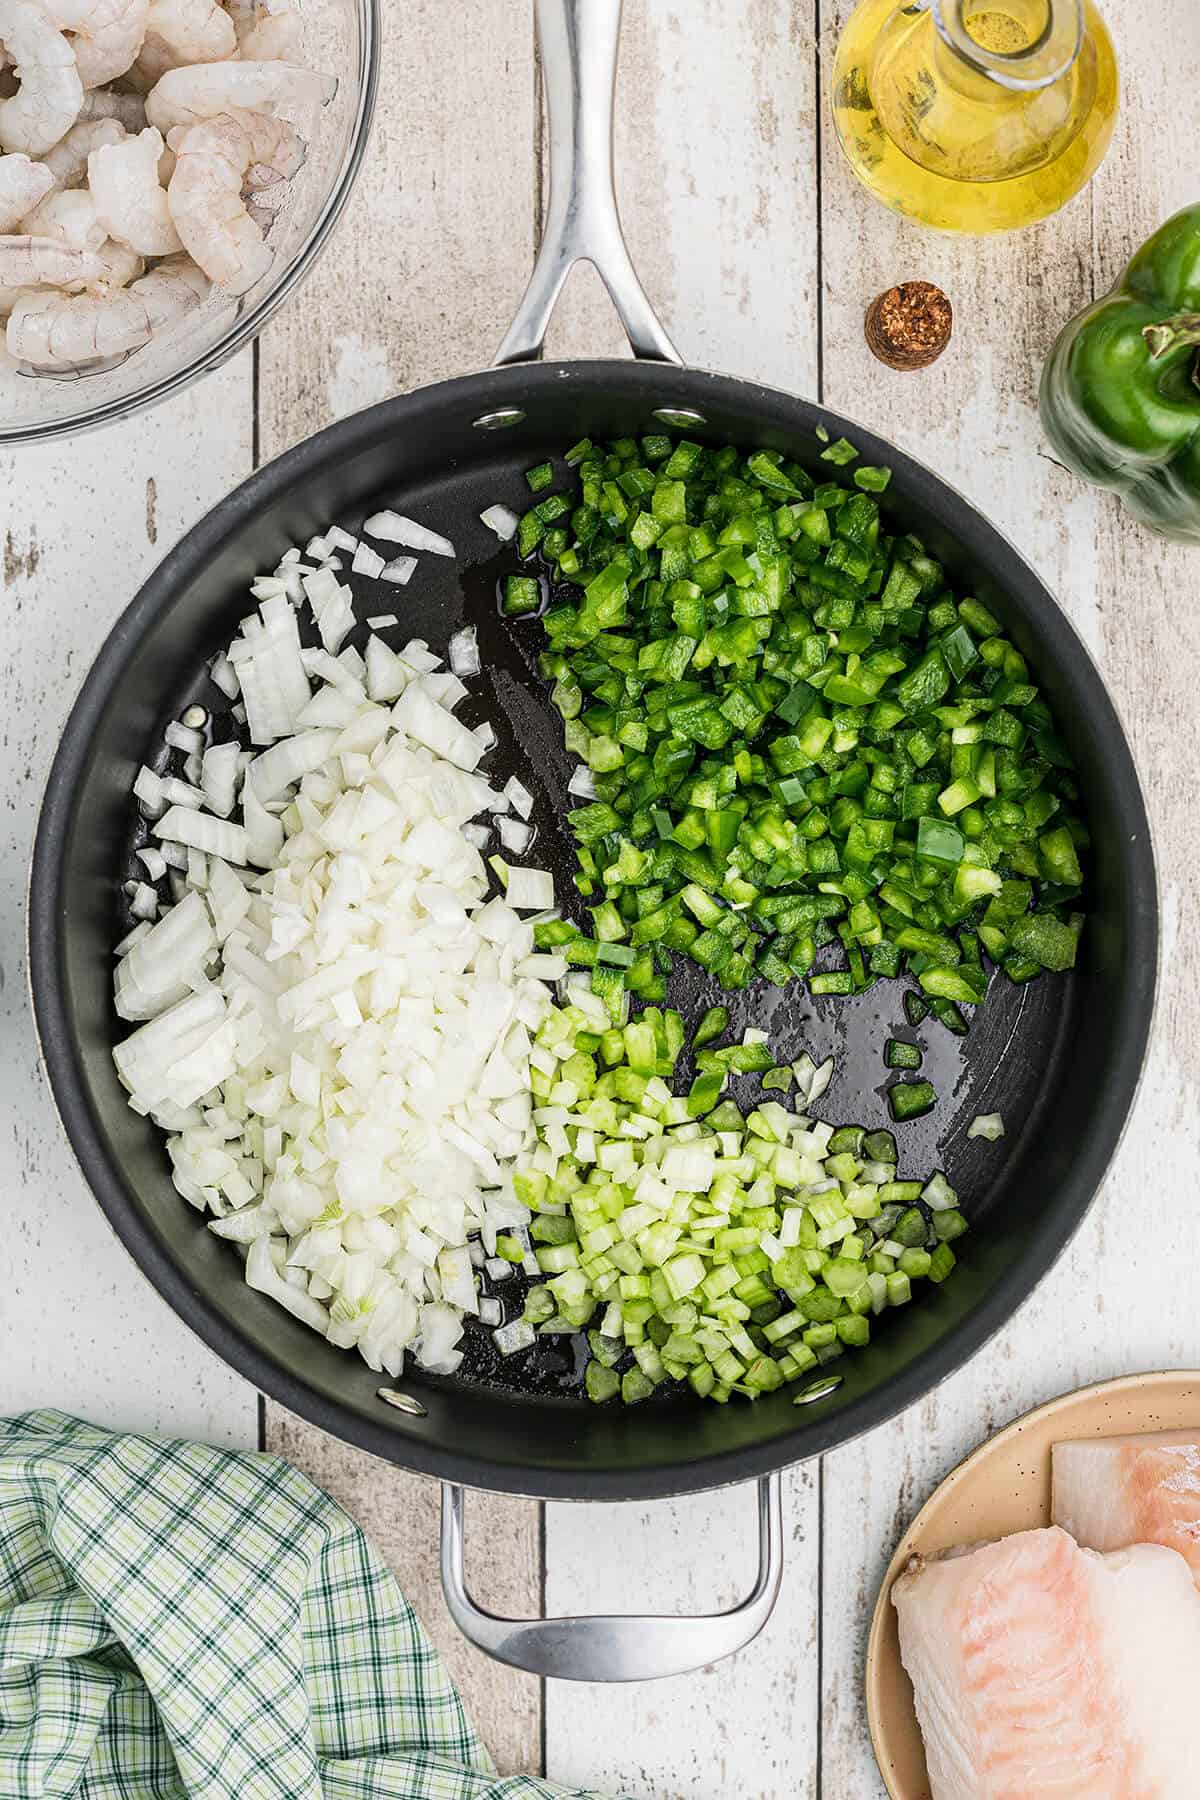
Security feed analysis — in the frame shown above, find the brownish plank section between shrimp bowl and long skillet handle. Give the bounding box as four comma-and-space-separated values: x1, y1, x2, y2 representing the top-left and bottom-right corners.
259, 0, 536, 459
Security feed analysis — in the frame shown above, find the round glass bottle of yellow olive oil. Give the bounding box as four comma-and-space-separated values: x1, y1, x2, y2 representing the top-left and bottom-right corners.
833, 0, 1117, 232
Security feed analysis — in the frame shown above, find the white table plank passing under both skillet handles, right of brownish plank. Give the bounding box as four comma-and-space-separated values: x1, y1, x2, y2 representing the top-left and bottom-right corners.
545, 0, 819, 1800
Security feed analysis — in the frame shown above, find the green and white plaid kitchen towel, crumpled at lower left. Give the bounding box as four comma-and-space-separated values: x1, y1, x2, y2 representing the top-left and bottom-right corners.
0, 1411, 618, 1800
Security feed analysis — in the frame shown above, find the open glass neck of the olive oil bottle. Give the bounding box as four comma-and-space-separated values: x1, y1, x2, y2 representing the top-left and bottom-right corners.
928, 0, 1085, 94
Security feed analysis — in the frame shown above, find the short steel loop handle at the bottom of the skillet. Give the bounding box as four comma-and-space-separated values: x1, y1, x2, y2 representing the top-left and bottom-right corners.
441, 1474, 783, 1681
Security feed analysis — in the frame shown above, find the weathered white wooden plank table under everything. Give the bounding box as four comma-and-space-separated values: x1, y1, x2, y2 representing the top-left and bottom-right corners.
0, 0, 1200, 1800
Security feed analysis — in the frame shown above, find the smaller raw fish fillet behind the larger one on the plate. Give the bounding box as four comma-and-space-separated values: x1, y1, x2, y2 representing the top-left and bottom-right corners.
1054, 1431, 1200, 1582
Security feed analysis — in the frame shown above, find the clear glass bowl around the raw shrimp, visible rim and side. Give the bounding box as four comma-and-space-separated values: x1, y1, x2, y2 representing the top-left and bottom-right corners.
0, 0, 380, 445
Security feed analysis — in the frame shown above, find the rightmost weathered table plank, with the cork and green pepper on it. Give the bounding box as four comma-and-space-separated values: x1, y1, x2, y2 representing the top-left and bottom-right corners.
820, 0, 1200, 1800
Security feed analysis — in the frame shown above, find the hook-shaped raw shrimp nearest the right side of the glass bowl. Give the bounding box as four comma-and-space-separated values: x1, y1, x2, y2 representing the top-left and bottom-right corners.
167, 108, 304, 293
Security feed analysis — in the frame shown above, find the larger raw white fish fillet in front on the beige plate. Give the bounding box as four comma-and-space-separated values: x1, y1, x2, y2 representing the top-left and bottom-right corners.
892, 1528, 1200, 1800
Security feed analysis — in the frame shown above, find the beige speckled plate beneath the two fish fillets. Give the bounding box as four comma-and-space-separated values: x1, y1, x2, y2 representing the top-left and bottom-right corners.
867, 1370, 1200, 1800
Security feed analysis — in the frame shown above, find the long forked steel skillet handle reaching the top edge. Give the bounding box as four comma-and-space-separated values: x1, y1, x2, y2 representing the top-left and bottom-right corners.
495, 0, 684, 367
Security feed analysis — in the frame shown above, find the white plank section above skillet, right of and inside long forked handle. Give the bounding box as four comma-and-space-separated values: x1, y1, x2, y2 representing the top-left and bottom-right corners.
547, 0, 817, 392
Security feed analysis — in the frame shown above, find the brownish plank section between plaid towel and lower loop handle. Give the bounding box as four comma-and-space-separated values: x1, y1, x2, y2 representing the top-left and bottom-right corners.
268, 1404, 542, 1775
